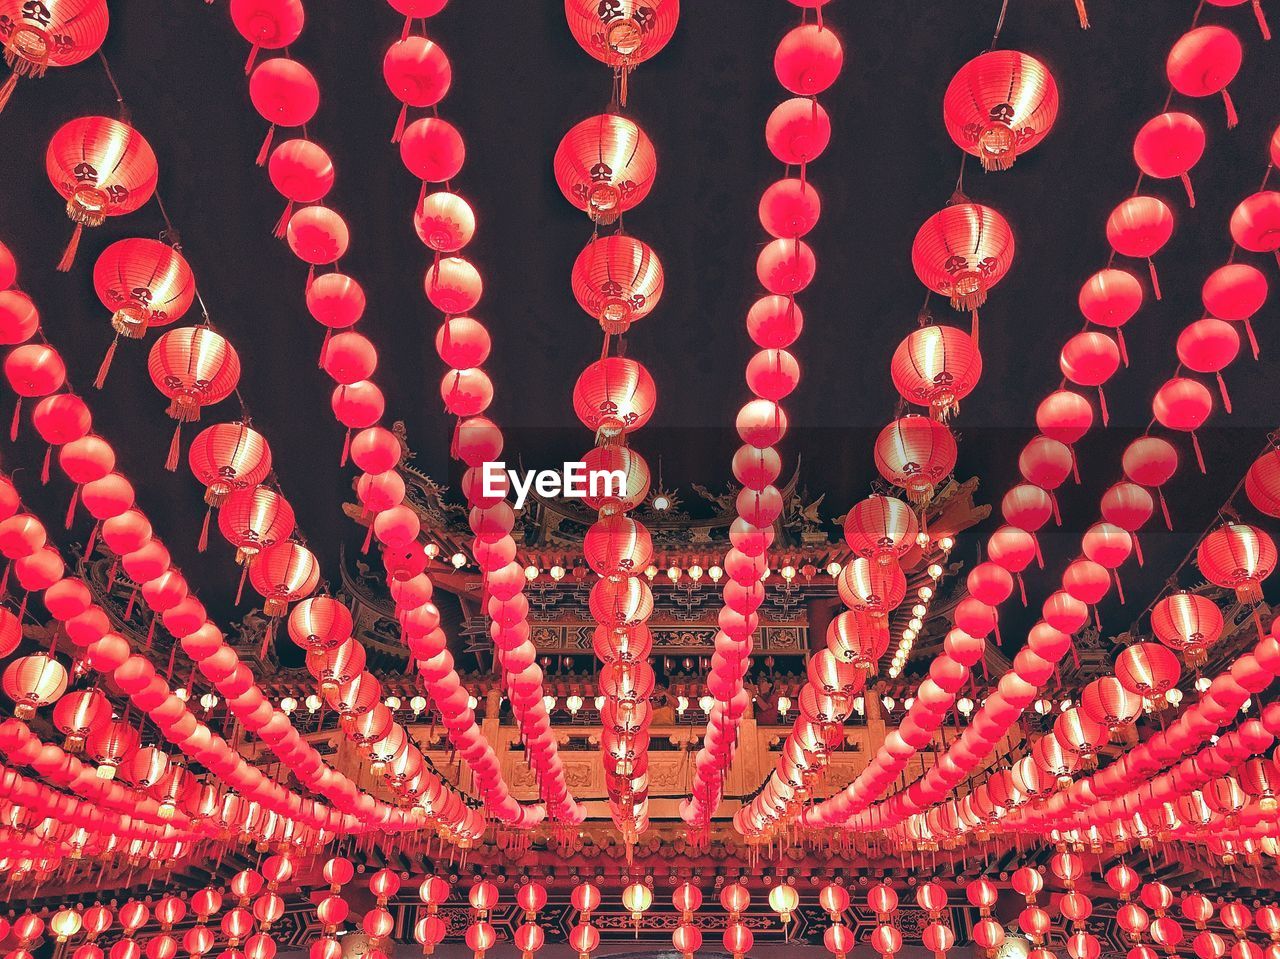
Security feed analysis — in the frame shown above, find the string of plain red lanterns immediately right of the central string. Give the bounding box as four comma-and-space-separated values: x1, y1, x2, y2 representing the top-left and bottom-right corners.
681, 3, 849, 834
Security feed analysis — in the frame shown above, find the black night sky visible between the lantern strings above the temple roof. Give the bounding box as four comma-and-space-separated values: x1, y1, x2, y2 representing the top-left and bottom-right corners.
0, 0, 1280, 650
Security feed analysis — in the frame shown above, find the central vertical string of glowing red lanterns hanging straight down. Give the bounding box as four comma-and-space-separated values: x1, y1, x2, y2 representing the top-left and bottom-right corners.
552, 0, 680, 845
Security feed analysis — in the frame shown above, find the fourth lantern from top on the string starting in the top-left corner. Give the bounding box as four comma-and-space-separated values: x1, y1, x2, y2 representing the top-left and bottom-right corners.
148, 323, 241, 472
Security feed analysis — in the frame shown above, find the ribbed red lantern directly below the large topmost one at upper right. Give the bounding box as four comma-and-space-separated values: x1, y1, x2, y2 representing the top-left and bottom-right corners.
911, 202, 1014, 330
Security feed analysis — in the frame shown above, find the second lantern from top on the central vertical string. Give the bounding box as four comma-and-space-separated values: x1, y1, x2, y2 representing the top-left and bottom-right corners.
552, 113, 658, 224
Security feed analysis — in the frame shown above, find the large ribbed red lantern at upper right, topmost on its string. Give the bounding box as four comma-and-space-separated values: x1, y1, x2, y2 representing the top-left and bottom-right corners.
942, 50, 1057, 170
